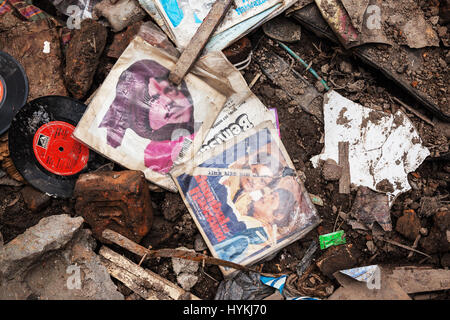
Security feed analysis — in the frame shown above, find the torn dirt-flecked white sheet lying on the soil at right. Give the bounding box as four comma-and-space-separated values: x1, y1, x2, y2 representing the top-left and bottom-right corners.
311, 91, 430, 205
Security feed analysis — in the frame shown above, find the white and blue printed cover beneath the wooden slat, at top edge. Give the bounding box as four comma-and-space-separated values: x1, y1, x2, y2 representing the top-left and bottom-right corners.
154, 0, 282, 48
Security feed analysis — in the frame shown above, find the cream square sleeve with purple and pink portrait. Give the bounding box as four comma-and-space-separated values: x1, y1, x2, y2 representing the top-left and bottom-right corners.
74, 36, 226, 192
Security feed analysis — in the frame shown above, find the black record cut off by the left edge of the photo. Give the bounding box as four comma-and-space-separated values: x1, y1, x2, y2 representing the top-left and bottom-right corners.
0, 51, 28, 135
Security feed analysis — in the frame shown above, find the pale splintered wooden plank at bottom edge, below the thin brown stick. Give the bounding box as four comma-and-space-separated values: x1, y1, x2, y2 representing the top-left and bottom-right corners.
99, 246, 200, 300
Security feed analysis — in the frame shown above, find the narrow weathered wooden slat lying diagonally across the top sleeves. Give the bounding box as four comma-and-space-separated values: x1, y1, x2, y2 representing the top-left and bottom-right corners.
169, 0, 233, 85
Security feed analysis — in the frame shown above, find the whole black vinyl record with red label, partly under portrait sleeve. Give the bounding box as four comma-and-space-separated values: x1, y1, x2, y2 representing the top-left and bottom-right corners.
8, 96, 104, 198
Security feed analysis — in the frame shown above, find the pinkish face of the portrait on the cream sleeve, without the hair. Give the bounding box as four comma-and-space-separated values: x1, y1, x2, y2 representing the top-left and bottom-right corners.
148, 78, 192, 130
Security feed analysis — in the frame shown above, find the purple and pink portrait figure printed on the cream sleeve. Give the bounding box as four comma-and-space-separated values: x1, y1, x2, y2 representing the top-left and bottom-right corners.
99, 60, 195, 173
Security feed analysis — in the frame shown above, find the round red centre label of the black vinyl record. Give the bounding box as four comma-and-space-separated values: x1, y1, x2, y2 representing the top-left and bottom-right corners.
33, 121, 89, 176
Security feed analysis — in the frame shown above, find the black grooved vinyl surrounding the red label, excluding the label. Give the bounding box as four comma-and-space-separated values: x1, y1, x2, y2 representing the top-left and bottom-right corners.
8, 96, 105, 198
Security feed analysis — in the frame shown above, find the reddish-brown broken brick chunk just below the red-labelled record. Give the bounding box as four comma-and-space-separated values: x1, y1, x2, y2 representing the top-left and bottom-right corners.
74, 170, 153, 243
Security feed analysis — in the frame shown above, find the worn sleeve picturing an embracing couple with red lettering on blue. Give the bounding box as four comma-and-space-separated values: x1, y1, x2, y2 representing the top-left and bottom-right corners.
171, 121, 320, 278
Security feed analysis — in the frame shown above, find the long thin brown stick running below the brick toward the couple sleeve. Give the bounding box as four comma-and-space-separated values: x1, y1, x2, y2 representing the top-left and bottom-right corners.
102, 229, 282, 277
